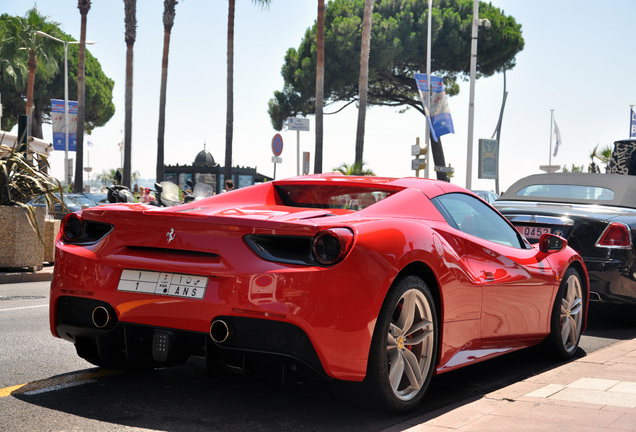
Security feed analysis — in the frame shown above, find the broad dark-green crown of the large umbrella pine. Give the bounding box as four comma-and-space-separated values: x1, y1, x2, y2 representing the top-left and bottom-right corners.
269, 0, 524, 130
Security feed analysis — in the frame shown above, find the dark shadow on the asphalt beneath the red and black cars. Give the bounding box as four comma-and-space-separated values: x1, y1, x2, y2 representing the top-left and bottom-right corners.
13, 305, 636, 432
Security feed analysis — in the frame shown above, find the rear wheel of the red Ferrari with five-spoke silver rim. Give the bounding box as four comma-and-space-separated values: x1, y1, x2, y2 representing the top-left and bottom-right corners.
362, 275, 439, 412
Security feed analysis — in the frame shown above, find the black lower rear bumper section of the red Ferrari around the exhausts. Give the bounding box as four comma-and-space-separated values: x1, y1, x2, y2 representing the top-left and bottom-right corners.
55, 296, 326, 376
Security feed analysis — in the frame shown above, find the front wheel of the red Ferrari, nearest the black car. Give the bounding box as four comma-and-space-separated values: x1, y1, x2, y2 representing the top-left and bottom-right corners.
546, 267, 586, 360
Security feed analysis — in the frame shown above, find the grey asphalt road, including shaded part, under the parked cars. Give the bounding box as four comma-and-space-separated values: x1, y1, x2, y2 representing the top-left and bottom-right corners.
0, 282, 636, 432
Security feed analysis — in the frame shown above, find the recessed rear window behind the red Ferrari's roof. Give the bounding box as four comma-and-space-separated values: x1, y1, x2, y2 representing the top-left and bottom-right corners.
276, 184, 397, 210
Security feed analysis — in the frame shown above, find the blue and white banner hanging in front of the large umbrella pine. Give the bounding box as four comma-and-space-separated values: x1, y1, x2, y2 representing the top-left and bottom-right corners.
415, 73, 455, 141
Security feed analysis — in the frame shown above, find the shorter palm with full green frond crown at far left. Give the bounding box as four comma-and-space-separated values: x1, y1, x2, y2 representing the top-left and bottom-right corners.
5, 7, 59, 138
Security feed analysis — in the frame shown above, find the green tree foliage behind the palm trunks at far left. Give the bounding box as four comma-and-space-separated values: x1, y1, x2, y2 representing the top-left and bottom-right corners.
0, 10, 115, 133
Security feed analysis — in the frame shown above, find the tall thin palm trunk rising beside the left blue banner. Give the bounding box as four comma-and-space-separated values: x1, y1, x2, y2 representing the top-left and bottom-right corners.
73, 0, 91, 192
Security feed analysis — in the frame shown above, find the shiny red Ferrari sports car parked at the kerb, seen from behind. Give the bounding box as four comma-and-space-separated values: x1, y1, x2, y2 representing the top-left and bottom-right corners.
50, 174, 589, 410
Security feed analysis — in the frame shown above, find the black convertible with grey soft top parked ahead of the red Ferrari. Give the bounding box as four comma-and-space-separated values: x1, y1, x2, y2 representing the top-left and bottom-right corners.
494, 173, 636, 303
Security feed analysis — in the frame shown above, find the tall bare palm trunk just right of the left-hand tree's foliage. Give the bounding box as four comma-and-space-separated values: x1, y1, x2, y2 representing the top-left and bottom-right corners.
122, 0, 137, 187
